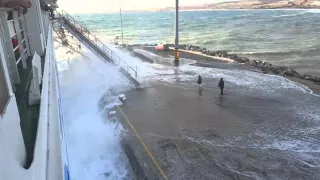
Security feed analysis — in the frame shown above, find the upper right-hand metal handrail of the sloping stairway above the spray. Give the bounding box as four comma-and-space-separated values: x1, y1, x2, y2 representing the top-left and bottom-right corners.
57, 11, 138, 79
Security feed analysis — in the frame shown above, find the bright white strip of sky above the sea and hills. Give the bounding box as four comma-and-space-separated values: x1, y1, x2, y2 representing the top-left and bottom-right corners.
58, 0, 232, 13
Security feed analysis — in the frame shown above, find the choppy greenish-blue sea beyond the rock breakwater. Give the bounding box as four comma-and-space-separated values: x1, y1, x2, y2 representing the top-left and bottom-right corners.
75, 9, 320, 75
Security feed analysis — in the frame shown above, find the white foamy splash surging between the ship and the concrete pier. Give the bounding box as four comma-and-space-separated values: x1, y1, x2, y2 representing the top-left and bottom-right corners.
56, 36, 132, 180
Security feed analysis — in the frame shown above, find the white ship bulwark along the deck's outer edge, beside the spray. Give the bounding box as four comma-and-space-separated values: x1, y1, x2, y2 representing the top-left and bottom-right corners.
30, 23, 70, 180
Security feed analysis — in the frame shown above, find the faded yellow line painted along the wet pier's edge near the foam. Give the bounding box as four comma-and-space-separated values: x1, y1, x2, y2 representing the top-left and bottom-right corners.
118, 106, 168, 180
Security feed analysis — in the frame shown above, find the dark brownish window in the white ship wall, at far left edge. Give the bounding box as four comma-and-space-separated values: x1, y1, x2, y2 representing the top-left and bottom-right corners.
0, 57, 9, 115
